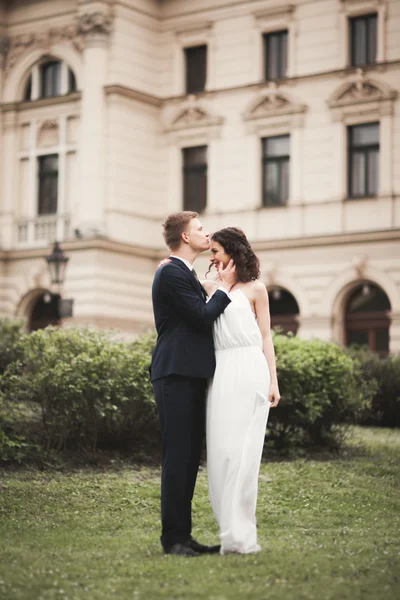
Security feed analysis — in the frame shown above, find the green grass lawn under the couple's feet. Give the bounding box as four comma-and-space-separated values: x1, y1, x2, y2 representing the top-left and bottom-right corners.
0, 428, 400, 600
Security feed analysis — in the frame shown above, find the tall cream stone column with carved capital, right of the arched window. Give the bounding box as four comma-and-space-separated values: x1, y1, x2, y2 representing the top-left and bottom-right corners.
78, 12, 111, 235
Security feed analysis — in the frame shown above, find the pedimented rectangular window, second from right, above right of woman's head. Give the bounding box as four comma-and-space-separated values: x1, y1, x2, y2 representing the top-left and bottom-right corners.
261, 135, 290, 206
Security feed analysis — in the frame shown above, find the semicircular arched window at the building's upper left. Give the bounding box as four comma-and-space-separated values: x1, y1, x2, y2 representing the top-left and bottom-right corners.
24, 57, 76, 102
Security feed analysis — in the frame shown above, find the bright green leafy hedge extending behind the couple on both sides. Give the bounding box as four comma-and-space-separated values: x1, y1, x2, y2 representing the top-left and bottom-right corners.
0, 322, 384, 460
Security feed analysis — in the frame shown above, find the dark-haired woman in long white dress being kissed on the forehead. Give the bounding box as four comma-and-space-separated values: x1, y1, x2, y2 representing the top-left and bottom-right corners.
202, 227, 280, 554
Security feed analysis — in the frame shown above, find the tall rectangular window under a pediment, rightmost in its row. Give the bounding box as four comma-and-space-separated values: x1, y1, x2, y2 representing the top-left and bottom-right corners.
348, 123, 379, 198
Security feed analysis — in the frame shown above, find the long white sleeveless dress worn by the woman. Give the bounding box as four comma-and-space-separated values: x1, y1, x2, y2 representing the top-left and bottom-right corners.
207, 289, 270, 554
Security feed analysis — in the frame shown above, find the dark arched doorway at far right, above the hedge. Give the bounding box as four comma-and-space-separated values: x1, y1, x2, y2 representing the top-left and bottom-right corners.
345, 282, 391, 356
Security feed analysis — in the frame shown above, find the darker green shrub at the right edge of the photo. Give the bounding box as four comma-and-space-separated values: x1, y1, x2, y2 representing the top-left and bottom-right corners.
348, 347, 400, 427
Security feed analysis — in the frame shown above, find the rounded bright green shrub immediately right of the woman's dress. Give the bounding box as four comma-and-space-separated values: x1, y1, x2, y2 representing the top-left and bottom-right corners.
267, 334, 369, 449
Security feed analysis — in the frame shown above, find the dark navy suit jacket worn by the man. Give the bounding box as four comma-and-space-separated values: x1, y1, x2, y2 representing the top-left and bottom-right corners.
150, 258, 230, 381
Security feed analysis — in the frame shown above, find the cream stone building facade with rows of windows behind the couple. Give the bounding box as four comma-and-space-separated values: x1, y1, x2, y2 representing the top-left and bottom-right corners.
0, 0, 400, 354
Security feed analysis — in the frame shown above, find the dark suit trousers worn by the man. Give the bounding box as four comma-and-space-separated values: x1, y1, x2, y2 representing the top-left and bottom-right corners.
153, 375, 207, 549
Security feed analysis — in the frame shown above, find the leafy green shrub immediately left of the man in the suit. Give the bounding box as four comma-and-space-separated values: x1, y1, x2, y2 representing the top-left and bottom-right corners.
1, 327, 158, 452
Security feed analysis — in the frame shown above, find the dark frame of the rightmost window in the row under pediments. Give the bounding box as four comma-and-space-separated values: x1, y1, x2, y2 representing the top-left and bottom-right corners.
347, 121, 381, 200
